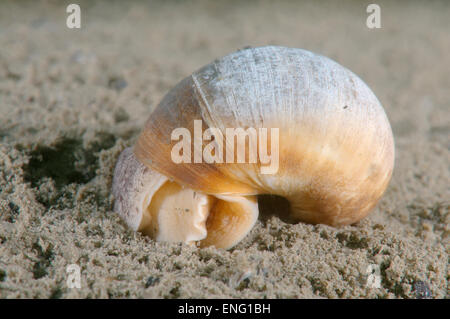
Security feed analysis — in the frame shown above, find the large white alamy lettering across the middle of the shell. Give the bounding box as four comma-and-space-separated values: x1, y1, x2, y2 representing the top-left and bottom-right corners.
170, 120, 279, 174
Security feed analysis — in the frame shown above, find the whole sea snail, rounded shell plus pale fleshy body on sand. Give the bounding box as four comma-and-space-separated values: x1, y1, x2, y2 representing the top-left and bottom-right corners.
113, 46, 394, 248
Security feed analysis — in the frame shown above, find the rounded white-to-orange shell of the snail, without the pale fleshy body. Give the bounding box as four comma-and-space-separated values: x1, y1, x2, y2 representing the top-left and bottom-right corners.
134, 46, 394, 226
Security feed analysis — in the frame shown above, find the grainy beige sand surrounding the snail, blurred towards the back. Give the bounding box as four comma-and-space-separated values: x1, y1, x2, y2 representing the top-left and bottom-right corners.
0, 1, 450, 298
